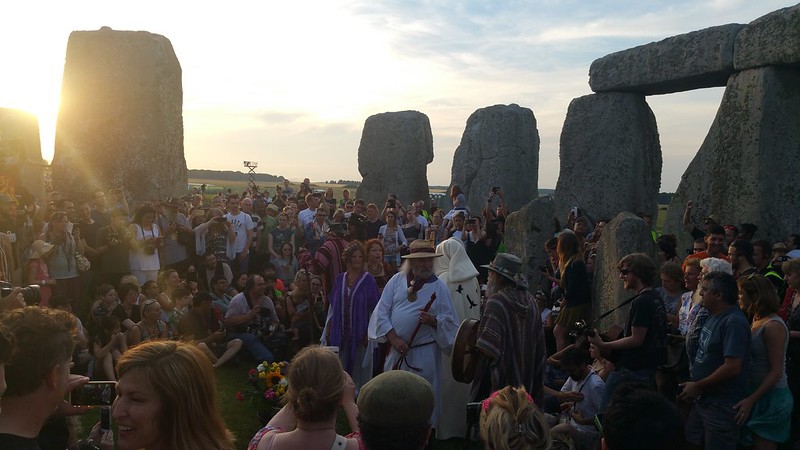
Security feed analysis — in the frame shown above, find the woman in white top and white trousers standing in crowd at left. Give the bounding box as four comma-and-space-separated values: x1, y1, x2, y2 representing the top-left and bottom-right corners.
128, 205, 164, 284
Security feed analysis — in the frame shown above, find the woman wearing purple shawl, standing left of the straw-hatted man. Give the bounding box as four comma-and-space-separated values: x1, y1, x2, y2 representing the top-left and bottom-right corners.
321, 241, 380, 392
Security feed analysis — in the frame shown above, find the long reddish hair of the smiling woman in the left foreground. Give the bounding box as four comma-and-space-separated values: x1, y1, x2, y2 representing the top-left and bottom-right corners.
117, 341, 234, 450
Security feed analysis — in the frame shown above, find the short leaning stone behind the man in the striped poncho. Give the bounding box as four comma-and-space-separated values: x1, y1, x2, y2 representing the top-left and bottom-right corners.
503, 196, 555, 291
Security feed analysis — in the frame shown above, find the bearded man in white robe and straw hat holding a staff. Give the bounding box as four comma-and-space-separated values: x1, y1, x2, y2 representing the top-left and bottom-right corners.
369, 239, 458, 428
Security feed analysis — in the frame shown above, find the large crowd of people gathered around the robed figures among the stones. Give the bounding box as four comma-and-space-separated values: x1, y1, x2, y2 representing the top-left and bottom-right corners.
0, 179, 800, 450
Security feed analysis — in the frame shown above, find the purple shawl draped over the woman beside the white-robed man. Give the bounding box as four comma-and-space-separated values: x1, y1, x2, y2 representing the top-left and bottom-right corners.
328, 271, 381, 373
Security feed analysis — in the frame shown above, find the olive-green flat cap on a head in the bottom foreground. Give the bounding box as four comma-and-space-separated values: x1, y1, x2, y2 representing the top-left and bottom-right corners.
358, 368, 434, 428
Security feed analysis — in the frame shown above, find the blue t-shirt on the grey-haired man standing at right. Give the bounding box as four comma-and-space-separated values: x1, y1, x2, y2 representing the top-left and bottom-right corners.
691, 306, 750, 403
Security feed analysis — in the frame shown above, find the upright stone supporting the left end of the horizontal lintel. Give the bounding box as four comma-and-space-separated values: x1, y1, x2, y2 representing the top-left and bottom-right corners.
555, 93, 661, 229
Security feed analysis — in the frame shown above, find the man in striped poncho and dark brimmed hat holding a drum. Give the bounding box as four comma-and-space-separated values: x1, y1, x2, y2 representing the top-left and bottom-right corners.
470, 253, 547, 405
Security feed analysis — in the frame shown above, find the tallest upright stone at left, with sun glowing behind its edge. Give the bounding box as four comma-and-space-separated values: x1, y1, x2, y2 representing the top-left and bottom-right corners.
52, 27, 187, 202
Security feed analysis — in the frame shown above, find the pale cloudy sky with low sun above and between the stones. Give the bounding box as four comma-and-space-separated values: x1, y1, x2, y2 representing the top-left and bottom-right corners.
0, 0, 792, 192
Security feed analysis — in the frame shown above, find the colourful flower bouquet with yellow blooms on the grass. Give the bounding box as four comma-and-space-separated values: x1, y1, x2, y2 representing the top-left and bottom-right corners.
236, 361, 289, 424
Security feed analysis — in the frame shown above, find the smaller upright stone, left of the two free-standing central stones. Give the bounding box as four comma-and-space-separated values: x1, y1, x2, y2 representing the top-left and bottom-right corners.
356, 111, 433, 206
